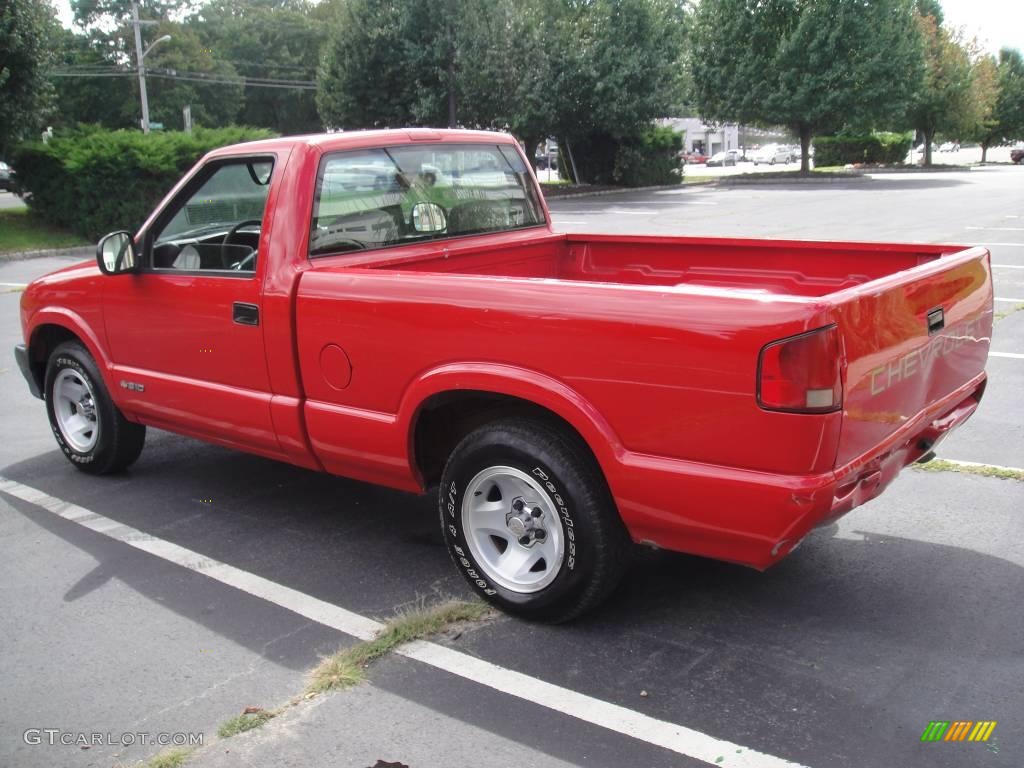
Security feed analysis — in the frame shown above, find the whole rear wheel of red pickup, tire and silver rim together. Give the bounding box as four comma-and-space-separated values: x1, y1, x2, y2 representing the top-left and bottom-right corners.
439, 419, 630, 623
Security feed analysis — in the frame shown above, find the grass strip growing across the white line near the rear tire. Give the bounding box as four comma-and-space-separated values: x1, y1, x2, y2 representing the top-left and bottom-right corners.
306, 600, 489, 693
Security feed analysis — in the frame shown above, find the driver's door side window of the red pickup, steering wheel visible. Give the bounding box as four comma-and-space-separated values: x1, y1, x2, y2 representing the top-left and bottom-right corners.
153, 158, 273, 274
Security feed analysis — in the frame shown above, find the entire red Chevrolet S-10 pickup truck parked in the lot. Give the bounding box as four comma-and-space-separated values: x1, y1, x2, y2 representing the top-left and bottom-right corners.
16, 129, 992, 621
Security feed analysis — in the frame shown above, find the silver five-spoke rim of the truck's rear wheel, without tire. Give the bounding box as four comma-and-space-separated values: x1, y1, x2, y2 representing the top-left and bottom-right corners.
462, 467, 565, 594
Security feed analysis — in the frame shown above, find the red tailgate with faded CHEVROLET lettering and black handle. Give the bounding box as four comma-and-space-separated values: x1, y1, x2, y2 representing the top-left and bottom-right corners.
829, 246, 992, 467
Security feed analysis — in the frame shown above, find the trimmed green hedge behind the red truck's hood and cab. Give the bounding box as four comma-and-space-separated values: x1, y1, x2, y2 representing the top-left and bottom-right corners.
13, 126, 273, 240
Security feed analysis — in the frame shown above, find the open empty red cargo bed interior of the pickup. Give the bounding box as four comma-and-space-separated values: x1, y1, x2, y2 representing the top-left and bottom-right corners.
364, 234, 962, 297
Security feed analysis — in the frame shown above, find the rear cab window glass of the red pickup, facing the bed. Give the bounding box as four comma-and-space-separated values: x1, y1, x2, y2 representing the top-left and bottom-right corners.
309, 143, 547, 257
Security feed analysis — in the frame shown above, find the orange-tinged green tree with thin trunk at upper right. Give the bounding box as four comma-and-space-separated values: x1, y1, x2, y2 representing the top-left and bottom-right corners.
911, 15, 978, 166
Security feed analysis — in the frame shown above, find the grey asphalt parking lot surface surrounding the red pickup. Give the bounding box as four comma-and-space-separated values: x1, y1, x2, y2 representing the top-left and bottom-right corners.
0, 167, 1024, 768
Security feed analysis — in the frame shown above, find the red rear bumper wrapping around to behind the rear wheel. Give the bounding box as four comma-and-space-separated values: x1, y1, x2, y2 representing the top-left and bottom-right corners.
609, 374, 986, 569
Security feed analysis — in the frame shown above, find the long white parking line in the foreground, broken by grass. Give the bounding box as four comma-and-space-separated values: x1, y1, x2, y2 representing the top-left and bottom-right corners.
0, 477, 804, 768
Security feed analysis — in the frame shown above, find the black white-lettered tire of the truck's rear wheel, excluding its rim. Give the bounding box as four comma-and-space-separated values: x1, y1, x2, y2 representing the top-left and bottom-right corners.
439, 430, 596, 620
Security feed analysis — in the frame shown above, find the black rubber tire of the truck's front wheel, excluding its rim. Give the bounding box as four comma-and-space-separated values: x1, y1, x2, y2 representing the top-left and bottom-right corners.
45, 343, 117, 472
